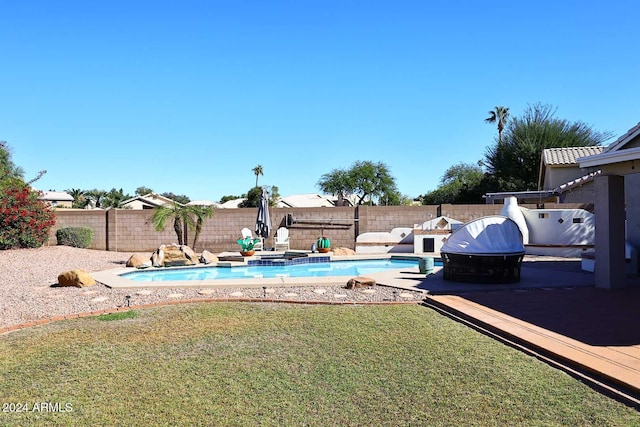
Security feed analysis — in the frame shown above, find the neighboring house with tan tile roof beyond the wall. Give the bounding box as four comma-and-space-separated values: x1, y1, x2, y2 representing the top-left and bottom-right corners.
485, 146, 605, 204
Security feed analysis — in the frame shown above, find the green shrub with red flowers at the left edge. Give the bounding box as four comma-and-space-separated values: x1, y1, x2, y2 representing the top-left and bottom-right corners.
0, 186, 55, 249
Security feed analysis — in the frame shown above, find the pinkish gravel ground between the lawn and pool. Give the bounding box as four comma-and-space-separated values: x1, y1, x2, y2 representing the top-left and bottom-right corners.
0, 246, 423, 328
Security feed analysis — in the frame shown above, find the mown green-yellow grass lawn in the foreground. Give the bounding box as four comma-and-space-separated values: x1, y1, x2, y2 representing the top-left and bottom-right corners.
0, 303, 640, 426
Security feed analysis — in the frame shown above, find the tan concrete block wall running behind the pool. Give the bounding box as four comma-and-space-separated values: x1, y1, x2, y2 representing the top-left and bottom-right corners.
46, 203, 593, 253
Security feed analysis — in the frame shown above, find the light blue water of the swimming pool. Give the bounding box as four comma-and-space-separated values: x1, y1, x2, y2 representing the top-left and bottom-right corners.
122, 259, 418, 282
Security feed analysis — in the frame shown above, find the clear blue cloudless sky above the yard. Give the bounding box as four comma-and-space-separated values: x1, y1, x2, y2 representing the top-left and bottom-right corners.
0, 0, 640, 201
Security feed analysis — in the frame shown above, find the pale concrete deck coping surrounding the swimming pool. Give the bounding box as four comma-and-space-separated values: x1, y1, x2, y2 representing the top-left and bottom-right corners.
91, 254, 438, 289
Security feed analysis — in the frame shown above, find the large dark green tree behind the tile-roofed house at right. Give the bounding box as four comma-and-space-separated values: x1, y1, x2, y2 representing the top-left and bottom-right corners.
483, 104, 612, 191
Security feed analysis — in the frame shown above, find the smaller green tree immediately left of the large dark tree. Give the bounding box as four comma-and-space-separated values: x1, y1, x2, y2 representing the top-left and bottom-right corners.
420, 163, 484, 205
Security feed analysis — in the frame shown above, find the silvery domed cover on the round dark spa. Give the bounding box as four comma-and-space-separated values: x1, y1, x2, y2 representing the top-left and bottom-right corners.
440, 215, 524, 255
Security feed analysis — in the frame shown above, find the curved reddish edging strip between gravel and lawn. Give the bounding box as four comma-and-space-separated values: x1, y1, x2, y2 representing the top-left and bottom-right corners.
0, 298, 423, 335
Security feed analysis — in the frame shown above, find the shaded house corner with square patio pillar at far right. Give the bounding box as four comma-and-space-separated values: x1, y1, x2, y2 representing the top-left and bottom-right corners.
577, 123, 640, 289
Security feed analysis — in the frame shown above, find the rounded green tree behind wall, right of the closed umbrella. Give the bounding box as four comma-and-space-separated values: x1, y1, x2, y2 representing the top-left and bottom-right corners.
317, 161, 398, 205
